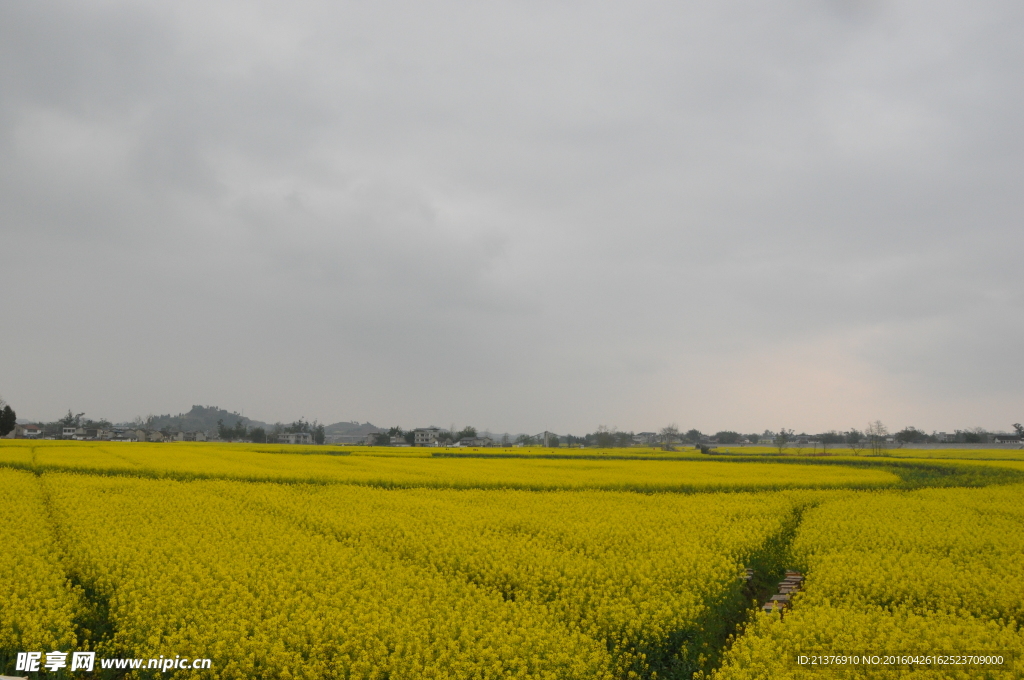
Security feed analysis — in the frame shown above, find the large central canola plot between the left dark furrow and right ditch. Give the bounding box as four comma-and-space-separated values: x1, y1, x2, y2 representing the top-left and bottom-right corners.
36, 474, 813, 678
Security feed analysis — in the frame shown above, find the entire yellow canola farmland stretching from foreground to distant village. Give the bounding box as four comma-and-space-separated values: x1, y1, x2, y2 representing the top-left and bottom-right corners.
0, 441, 1024, 680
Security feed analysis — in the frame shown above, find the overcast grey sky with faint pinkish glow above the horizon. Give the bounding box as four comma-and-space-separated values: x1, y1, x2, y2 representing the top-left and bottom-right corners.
0, 0, 1024, 433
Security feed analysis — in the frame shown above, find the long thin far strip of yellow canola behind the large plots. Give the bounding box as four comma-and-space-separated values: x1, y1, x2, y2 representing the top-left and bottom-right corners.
0, 440, 899, 492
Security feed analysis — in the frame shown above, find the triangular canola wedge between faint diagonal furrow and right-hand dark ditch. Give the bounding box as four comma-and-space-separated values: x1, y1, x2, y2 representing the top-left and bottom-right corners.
226, 485, 807, 673
